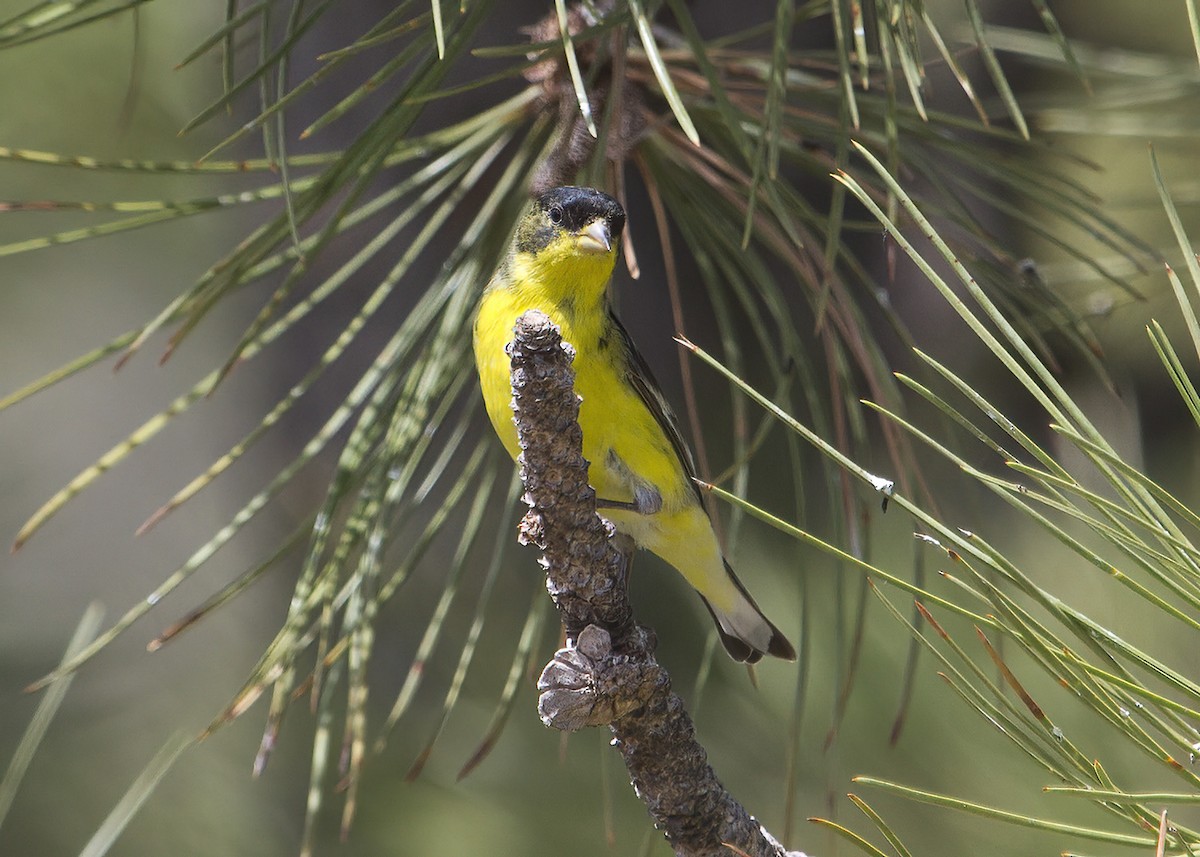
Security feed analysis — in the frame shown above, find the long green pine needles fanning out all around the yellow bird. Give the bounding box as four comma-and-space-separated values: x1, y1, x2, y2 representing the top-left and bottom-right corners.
0, 0, 1200, 857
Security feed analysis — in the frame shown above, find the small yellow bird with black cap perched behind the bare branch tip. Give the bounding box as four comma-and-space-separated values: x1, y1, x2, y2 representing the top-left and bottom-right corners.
474, 187, 796, 663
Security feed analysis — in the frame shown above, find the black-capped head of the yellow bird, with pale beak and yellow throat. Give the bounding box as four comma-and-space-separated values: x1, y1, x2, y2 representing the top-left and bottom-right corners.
514, 187, 625, 293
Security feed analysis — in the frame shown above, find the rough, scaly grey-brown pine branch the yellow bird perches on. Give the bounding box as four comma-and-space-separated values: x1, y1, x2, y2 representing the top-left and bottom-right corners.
509, 310, 803, 857
